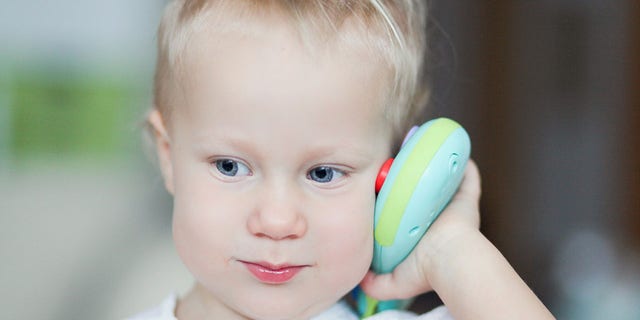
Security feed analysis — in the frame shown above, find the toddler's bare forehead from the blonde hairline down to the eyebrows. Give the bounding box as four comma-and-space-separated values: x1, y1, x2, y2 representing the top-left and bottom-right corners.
165, 17, 390, 158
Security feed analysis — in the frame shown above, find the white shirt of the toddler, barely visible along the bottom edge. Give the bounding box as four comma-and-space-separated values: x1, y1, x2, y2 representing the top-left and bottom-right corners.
127, 294, 453, 320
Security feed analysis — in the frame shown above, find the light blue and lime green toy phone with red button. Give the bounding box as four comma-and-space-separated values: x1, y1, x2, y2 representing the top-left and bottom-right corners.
356, 118, 471, 317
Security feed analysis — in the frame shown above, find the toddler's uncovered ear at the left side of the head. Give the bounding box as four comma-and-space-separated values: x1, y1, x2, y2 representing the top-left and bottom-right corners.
147, 108, 174, 195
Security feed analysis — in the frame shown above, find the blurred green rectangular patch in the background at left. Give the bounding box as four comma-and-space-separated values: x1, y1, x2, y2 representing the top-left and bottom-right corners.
9, 70, 141, 160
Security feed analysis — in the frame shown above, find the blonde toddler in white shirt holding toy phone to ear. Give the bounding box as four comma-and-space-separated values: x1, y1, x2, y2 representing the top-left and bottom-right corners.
135, 0, 552, 320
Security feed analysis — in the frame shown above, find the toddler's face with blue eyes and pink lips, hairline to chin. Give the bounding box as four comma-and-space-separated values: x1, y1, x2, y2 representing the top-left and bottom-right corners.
161, 21, 390, 319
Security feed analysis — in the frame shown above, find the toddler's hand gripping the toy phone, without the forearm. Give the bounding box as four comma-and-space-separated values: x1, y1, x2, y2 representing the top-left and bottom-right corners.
361, 160, 480, 300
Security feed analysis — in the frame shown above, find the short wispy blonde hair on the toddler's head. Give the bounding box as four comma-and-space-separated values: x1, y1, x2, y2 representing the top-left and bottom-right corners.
154, 0, 428, 145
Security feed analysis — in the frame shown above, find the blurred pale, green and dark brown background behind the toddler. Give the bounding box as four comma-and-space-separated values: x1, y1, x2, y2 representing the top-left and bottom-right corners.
0, 0, 640, 319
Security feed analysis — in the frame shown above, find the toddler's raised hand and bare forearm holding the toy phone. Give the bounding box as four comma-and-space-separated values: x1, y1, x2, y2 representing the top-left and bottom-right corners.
361, 161, 554, 320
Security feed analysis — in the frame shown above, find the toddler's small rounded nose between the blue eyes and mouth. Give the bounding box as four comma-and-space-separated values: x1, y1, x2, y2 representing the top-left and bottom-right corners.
247, 185, 307, 240
